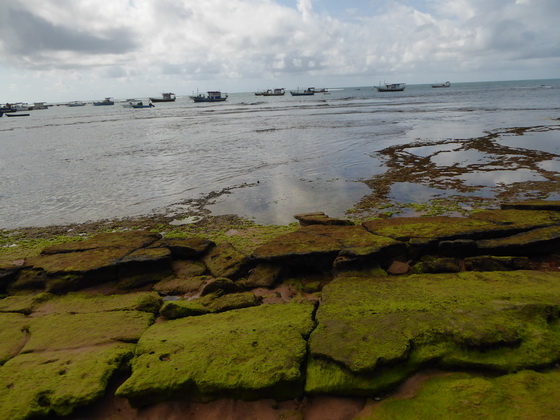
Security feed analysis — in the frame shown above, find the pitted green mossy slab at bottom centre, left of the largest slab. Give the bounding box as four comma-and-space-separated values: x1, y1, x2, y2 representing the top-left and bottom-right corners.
117, 303, 314, 406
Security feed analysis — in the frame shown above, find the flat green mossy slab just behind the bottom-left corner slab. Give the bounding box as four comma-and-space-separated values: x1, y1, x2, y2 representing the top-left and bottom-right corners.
22, 311, 154, 353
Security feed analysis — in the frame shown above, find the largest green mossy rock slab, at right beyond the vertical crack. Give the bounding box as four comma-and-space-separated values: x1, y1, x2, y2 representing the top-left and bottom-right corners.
306, 271, 560, 395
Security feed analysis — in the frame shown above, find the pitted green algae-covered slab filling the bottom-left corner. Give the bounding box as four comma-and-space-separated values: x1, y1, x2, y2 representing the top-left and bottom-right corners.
0, 343, 134, 420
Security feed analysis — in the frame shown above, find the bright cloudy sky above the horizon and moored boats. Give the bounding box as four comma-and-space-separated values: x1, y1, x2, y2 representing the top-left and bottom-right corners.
0, 0, 560, 103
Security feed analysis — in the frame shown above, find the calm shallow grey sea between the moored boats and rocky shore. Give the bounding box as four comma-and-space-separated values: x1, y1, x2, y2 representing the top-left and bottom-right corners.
0, 80, 560, 228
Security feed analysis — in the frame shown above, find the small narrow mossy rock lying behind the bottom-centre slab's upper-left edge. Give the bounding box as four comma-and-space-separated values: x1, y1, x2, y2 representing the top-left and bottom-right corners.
160, 292, 261, 319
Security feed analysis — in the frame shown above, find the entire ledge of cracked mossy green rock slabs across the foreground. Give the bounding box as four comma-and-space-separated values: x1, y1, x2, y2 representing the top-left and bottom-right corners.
0, 201, 560, 420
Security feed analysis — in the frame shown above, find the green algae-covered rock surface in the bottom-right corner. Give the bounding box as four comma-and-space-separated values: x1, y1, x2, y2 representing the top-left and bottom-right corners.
356, 371, 560, 420
